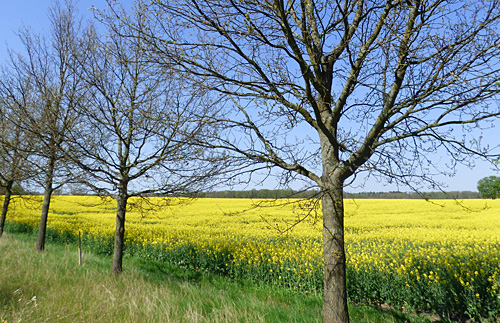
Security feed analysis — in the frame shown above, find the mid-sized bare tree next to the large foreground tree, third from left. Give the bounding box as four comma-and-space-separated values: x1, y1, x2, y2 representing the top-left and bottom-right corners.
74, 17, 223, 273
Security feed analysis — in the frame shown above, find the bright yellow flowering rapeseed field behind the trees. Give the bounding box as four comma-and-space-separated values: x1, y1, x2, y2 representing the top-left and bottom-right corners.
3, 196, 500, 316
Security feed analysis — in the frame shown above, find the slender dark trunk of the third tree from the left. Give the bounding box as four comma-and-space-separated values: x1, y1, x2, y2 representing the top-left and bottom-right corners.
112, 184, 128, 274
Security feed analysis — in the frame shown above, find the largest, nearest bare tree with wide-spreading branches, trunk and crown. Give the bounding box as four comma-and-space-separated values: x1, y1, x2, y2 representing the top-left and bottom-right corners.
117, 0, 500, 322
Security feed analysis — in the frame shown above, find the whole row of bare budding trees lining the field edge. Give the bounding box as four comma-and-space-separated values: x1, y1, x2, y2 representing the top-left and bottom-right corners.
0, 0, 500, 322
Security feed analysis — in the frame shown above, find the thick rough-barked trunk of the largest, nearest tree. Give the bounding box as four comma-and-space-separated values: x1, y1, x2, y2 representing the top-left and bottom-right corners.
321, 136, 349, 323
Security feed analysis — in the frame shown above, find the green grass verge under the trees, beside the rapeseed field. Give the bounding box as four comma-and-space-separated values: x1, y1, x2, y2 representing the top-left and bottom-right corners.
0, 233, 430, 323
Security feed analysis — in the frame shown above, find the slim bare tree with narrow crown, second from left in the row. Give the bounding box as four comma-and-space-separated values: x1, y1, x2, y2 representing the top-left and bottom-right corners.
4, 2, 83, 251
